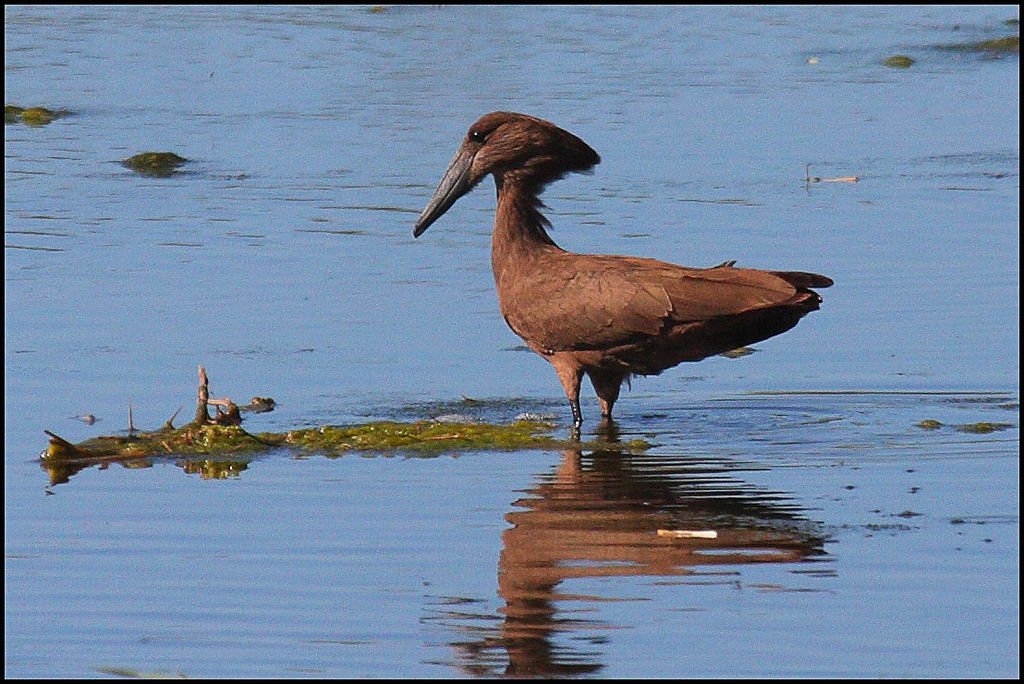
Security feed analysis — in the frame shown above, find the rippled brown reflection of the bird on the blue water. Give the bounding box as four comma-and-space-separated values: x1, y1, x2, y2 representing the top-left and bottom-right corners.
436, 450, 825, 677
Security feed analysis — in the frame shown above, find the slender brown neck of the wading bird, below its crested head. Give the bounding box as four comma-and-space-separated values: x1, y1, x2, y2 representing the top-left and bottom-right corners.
490, 178, 560, 287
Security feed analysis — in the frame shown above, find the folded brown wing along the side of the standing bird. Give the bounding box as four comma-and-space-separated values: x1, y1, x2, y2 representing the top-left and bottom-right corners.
502, 254, 799, 350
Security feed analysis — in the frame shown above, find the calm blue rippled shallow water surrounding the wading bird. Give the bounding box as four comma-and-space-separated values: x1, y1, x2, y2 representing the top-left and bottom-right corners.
4, 6, 1020, 677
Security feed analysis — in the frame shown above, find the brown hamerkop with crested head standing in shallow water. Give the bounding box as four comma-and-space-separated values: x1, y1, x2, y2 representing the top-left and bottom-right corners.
413, 112, 833, 434
